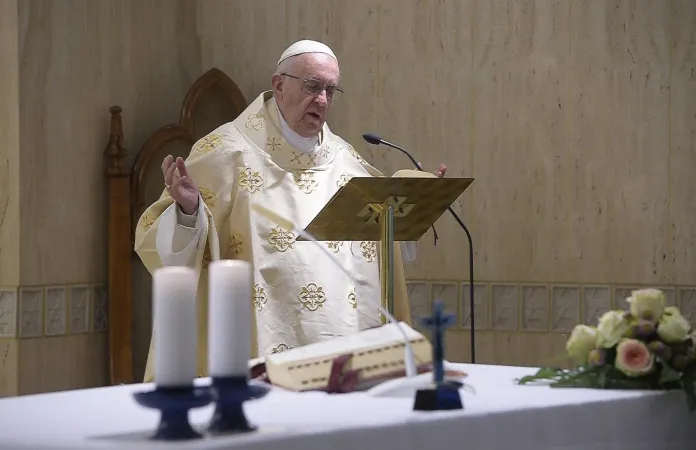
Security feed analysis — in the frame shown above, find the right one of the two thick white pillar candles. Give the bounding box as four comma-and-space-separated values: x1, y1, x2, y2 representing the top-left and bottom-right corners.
208, 260, 253, 377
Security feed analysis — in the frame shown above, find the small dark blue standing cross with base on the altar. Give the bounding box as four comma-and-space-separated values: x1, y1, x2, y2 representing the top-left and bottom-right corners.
413, 300, 464, 411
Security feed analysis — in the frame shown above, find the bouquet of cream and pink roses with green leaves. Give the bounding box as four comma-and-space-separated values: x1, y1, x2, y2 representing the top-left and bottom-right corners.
518, 289, 696, 411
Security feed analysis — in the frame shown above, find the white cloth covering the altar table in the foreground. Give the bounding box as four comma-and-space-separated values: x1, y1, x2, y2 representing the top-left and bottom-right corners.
0, 364, 696, 450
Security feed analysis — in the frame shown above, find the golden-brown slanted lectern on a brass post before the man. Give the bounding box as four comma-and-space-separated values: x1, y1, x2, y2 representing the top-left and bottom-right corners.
298, 176, 474, 323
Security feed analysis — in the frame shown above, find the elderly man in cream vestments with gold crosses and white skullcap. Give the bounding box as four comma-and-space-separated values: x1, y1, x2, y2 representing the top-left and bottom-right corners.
135, 40, 446, 381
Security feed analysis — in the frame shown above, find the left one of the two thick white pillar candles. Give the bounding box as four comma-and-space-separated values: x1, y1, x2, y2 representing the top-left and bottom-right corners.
152, 267, 198, 387
